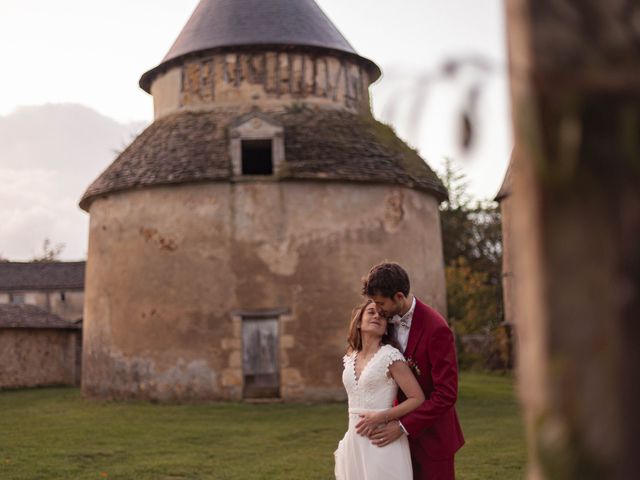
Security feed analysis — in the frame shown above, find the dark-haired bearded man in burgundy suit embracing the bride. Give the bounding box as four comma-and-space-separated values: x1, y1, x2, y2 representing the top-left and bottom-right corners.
356, 263, 464, 480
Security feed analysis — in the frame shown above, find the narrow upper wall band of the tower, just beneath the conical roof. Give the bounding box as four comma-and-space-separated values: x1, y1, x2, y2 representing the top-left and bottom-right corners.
151, 51, 371, 118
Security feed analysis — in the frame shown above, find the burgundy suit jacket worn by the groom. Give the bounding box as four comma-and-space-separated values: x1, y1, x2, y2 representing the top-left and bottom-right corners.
398, 298, 464, 462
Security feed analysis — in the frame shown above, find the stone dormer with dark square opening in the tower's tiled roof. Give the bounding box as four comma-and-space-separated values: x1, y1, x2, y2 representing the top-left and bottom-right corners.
229, 112, 284, 179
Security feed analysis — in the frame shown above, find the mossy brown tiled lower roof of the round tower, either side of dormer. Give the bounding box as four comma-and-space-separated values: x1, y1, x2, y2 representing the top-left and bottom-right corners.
80, 109, 447, 210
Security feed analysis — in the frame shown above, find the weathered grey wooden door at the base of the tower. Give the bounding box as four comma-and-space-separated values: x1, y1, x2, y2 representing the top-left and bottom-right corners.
242, 318, 280, 398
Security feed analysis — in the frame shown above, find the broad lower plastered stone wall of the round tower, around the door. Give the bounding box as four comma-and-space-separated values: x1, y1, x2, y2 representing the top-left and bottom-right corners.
82, 181, 445, 401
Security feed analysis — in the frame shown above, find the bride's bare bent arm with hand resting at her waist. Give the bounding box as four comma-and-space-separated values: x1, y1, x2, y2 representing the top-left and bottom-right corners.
356, 361, 424, 430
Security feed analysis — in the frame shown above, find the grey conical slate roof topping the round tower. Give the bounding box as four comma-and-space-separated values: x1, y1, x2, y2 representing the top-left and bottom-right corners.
140, 0, 380, 92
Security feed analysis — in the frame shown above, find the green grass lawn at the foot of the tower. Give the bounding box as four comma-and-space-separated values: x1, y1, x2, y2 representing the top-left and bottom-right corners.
0, 373, 525, 480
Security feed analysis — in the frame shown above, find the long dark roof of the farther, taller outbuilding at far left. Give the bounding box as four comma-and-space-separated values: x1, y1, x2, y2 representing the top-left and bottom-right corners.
0, 262, 86, 291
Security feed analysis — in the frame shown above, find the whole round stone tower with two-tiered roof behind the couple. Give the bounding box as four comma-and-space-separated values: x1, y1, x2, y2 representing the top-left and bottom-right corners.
80, 0, 446, 401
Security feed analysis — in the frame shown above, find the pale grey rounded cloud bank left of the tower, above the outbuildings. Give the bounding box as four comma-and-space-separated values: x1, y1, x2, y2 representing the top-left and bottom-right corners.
0, 104, 146, 260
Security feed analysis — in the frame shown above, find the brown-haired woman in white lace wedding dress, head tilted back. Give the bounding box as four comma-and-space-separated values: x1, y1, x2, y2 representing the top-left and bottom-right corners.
334, 300, 424, 480
